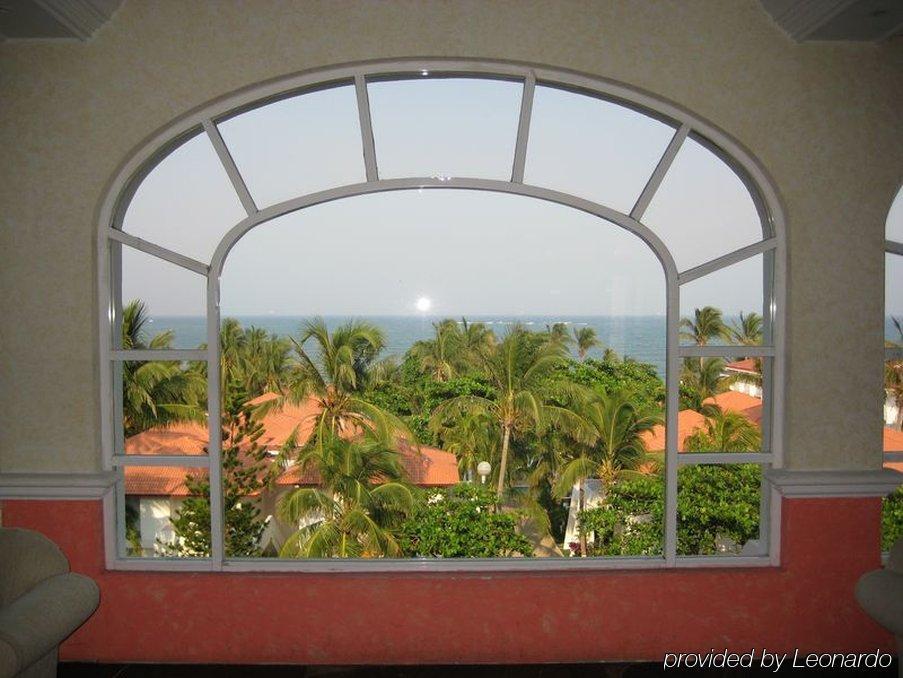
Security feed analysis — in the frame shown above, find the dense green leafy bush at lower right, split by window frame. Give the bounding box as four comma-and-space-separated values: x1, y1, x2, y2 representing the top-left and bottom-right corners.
578, 464, 762, 556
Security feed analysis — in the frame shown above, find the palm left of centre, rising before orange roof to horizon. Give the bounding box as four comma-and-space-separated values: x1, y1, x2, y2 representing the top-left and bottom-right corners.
286, 318, 410, 447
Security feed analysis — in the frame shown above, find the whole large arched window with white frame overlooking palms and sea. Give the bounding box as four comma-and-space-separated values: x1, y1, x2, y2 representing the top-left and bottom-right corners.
99, 60, 784, 570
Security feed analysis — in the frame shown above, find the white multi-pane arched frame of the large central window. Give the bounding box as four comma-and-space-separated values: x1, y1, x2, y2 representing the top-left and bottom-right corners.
97, 58, 784, 572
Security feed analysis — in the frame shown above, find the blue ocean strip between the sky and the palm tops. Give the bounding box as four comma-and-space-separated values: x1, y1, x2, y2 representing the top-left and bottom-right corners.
149, 315, 665, 375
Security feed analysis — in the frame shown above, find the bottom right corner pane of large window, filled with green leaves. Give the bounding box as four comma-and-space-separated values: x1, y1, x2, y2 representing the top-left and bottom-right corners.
677, 464, 762, 556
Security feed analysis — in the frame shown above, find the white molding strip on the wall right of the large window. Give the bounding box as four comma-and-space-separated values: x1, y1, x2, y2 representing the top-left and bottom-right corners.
765, 469, 903, 499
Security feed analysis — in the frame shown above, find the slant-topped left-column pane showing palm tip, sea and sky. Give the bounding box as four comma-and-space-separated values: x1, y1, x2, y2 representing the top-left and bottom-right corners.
122, 245, 207, 348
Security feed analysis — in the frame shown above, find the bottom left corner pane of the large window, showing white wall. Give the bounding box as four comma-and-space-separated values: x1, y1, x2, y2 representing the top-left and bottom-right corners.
120, 466, 210, 558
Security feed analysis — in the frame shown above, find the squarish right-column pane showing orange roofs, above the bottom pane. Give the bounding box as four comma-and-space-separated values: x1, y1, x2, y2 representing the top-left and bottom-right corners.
678, 357, 770, 453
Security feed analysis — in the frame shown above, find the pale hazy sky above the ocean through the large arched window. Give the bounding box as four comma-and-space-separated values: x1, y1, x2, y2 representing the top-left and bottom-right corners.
123, 78, 800, 316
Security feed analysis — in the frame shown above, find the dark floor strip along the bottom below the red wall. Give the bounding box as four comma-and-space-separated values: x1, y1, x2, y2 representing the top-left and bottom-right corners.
58, 663, 897, 678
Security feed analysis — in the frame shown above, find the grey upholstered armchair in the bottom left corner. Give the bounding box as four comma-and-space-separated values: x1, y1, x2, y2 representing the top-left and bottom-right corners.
0, 528, 100, 678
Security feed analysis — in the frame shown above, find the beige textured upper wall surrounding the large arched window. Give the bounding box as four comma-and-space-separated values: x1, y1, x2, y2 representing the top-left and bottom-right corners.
0, 0, 903, 472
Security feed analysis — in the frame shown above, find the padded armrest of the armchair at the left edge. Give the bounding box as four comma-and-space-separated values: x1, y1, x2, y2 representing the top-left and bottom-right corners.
0, 573, 100, 671
